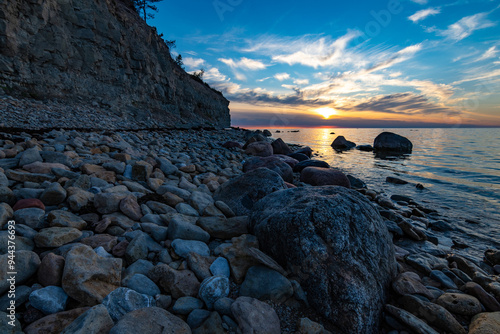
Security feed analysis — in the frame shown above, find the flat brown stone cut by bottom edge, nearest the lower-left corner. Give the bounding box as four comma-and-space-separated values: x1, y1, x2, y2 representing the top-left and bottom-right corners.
23, 307, 89, 334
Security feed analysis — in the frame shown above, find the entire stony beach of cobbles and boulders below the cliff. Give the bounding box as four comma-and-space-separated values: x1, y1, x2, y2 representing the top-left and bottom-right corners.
0, 128, 500, 334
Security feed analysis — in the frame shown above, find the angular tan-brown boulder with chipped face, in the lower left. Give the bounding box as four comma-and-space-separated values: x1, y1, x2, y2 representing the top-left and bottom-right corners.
62, 245, 122, 306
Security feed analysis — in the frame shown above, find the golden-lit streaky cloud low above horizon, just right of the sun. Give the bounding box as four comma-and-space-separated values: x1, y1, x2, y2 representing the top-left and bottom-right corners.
348, 92, 460, 116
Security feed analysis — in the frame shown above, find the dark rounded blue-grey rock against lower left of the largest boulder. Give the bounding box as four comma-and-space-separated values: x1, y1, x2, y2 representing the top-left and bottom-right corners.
240, 266, 293, 303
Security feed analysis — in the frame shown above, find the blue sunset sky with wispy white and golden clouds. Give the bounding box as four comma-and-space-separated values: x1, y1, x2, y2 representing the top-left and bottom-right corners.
148, 0, 500, 128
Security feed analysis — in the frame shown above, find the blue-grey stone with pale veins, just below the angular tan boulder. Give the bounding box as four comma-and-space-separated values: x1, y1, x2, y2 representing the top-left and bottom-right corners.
102, 288, 156, 322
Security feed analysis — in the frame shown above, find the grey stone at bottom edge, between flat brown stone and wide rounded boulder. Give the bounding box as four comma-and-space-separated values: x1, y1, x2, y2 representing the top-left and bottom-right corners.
61, 304, 114, 334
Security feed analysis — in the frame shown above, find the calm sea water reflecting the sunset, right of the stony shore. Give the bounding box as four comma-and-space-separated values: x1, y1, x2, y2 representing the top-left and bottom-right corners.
271, 128, 500, 251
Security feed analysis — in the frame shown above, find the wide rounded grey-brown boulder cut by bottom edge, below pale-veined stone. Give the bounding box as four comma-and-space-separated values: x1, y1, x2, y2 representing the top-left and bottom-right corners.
109, 307, 191, 334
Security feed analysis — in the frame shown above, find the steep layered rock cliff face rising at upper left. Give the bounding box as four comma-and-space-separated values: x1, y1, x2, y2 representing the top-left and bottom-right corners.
0, 0, 230, 128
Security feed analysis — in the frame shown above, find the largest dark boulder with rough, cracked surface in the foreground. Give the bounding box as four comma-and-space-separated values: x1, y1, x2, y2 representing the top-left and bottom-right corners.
250, 186, 396, 333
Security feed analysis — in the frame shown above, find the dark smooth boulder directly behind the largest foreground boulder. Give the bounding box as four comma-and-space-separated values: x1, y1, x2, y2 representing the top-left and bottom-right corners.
214, 168, 287, 216
